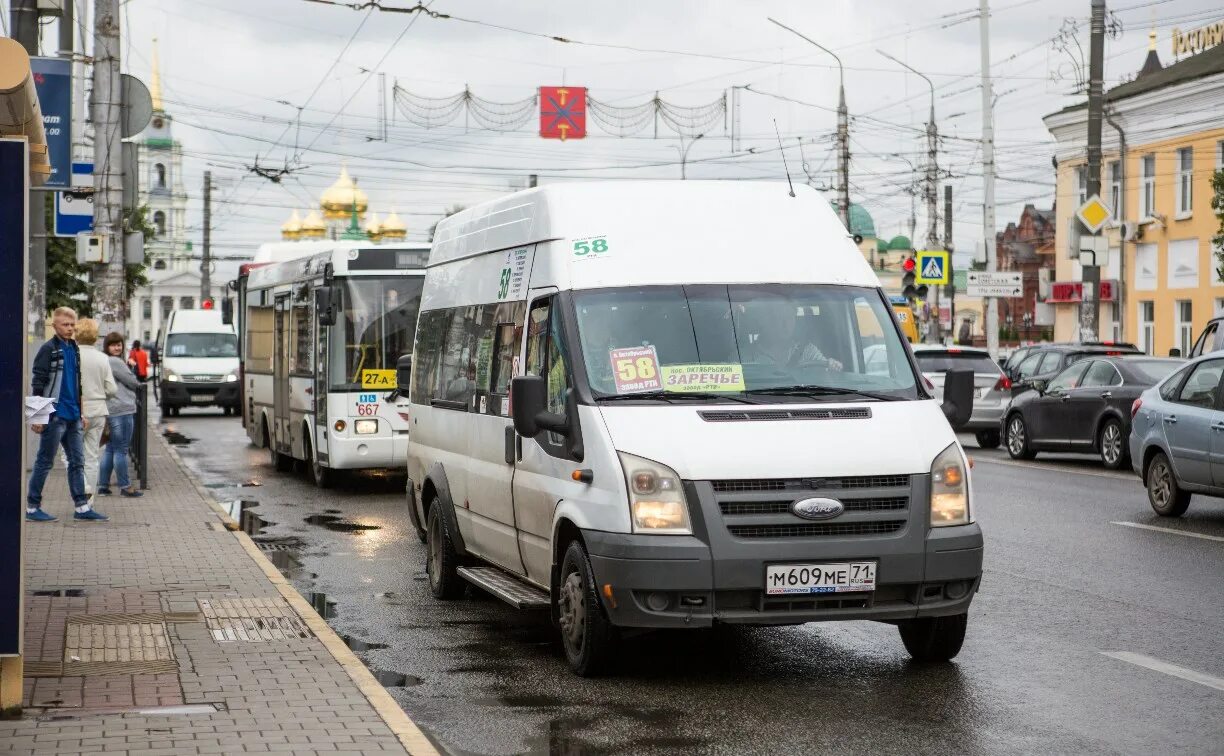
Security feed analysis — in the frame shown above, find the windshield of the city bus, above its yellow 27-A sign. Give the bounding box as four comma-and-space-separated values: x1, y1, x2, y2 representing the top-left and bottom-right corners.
329, 275, 422, 391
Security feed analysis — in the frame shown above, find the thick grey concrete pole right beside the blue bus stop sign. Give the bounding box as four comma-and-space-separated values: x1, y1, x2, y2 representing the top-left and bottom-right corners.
91, 0, 127, 330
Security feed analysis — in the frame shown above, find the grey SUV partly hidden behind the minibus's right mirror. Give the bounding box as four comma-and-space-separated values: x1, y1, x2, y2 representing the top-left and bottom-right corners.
913, 344, 1011, 449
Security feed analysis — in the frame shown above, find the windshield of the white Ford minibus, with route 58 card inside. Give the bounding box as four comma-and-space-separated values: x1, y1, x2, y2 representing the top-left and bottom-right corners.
574, 284, 919, 401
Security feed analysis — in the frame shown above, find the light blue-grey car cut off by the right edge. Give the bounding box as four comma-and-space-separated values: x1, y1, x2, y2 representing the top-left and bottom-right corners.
1130, 354, 1224, 517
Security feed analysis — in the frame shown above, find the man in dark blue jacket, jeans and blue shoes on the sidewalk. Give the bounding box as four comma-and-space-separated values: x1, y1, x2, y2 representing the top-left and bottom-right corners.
26, 307, 108, 522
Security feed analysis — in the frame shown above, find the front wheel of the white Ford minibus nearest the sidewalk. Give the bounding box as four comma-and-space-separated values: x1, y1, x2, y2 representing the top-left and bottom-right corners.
557, 541, 618, 678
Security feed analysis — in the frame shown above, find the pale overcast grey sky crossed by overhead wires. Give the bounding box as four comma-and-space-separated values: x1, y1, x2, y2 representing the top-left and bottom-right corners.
33, 0, 1224, 254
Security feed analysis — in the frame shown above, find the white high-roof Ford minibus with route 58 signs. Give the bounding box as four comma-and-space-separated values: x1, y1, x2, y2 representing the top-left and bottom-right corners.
408, 181, 982, 674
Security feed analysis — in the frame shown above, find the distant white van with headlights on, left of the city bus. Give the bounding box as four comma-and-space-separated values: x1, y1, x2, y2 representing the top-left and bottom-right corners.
154, 309, 241, 417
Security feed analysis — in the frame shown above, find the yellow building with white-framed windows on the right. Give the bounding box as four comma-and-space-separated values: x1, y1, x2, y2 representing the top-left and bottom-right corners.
1043, 32, 1224, 355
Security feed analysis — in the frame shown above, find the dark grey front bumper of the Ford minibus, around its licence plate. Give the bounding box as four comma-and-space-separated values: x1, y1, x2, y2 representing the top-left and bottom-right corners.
583, 476, 983, 628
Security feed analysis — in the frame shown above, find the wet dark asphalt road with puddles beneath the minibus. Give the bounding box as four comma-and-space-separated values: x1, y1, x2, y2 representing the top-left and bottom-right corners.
162, 411, 1224, 756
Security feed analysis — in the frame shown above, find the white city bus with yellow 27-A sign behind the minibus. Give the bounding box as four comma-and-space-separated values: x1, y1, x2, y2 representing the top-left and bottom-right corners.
225, 242, 430, 487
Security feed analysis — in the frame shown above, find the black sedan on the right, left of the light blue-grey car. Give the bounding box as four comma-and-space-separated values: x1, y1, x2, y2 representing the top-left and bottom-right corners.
1002, 355, 1185, 470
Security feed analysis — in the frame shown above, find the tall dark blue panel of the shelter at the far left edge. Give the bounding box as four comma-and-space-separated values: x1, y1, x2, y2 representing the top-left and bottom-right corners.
0, 139, 29, 656
